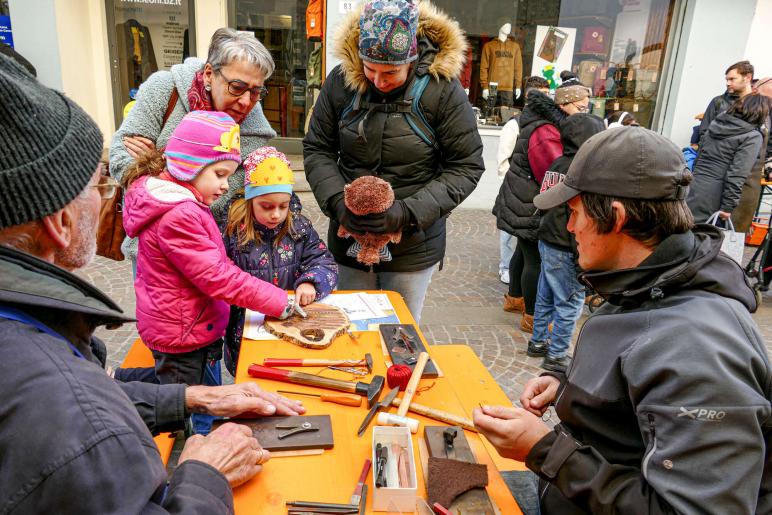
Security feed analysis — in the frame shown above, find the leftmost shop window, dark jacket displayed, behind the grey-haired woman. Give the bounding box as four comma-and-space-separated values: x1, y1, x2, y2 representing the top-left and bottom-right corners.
106, 0, 195, 124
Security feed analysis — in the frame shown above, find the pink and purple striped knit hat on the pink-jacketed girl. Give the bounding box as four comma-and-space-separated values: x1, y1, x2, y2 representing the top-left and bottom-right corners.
164, 111, 241, 182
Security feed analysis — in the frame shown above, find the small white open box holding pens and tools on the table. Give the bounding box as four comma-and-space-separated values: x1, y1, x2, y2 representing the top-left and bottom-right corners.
372, 426, 418, 513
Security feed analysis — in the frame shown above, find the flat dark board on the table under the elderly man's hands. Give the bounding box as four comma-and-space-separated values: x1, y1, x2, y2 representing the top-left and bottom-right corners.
213, 415, 334, 451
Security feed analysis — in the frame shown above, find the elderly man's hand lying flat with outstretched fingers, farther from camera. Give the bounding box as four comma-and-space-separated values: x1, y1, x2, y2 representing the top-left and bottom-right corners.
185, 383, 306, 417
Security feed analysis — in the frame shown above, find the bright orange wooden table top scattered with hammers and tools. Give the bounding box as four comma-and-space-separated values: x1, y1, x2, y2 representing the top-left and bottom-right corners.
234, 292, 524, 515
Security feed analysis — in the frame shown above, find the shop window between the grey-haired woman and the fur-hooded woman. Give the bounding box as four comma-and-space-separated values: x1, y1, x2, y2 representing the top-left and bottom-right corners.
230, 0, 324, 138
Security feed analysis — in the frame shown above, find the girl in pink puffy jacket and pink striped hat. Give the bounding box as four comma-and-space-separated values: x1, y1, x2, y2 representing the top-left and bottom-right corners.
123, 111, 293, 385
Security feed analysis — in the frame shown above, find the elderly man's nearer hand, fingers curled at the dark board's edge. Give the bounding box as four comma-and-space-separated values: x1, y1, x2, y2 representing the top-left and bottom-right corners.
178, 423, 271, 487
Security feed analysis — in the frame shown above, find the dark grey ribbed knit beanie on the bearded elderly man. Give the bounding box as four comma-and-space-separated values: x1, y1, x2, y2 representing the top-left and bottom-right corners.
0, 55, 103, 229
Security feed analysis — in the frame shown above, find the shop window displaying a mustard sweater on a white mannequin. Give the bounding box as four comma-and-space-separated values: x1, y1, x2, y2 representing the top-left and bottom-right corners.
435, 0, 675, 127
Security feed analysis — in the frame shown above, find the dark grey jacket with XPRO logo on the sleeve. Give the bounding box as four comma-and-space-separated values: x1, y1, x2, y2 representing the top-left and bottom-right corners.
526, 225, 772, 515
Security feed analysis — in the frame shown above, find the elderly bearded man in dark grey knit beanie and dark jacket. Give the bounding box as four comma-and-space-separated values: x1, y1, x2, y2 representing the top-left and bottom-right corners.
0, 55, 303, 513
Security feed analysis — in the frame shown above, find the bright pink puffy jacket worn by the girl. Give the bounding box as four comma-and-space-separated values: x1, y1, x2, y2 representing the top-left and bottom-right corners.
123, 177, 287, 353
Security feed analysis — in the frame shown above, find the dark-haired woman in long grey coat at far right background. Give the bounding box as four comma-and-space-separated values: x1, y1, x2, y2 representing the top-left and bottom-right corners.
687, 94, 769, 226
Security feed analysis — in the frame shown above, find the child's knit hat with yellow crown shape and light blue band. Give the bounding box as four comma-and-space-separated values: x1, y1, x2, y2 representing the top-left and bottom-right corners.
244, 147, 295, 200
